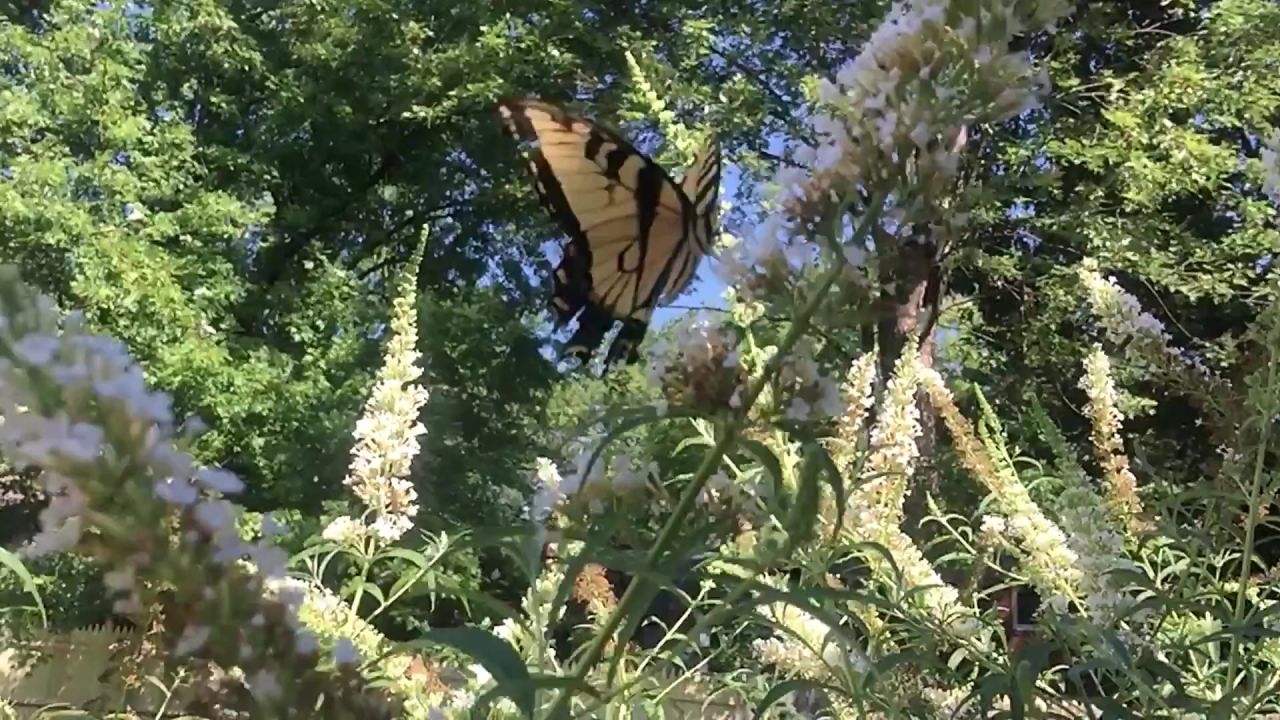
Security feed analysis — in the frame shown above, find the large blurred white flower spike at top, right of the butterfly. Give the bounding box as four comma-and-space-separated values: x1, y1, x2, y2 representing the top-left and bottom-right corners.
722, 0, 1071, 297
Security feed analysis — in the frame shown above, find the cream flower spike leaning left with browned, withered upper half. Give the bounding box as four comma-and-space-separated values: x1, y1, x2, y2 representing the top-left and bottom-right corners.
918, 365, 1082, 610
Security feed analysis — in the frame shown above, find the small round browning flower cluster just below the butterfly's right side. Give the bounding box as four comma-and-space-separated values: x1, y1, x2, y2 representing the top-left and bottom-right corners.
645, 313, 745, 411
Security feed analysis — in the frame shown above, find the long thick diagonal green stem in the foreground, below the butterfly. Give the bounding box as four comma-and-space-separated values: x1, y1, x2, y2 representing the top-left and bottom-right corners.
549, 193, 884, 719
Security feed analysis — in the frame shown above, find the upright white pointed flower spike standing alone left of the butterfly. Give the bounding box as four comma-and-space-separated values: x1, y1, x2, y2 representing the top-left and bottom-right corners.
324, 249, 428, 544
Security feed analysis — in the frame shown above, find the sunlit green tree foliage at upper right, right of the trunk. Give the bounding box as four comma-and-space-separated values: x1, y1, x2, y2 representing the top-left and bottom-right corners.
943, 0, 1280, 483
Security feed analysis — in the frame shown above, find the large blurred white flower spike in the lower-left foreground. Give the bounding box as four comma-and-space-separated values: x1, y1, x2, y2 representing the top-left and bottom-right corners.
0, 266, 393, 717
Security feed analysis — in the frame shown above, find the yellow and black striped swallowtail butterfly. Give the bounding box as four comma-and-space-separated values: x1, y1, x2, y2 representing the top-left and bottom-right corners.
498, 99, 721, 366
